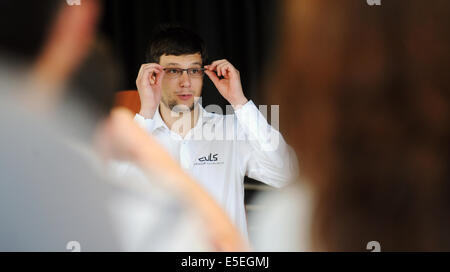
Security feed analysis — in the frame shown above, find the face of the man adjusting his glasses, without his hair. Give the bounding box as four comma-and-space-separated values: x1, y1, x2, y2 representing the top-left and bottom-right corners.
159, 53, 203, 111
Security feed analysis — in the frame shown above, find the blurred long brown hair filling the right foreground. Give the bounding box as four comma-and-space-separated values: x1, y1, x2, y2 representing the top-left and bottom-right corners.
266, 0, 450, 251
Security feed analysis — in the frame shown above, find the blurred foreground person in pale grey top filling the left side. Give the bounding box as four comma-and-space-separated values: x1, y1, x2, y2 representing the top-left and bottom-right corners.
0, 0, 245, 251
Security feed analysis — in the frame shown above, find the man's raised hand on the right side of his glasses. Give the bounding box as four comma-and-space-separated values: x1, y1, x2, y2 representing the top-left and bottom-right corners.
205, 59, 248, 108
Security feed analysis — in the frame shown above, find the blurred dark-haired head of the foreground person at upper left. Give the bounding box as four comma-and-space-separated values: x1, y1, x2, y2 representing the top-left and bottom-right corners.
0, 0, 114, 120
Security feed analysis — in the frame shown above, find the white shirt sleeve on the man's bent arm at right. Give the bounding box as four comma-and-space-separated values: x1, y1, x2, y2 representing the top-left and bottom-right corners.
235, 101, 298, 188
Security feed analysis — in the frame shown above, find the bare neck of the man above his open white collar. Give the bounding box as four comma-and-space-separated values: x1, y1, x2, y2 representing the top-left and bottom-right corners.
159, 103, 200, 137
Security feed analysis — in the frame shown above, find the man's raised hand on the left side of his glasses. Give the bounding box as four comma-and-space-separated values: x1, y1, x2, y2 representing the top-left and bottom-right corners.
136, 63, 164, 119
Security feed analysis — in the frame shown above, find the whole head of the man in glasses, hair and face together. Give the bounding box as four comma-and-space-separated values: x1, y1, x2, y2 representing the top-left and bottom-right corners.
146, 26, 206, 110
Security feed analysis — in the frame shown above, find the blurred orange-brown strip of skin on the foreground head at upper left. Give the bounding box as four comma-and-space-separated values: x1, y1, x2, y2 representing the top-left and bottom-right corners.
32, 0, 100, 86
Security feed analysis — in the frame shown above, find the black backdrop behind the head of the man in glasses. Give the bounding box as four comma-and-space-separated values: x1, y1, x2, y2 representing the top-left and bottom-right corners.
100, 0, 281, 108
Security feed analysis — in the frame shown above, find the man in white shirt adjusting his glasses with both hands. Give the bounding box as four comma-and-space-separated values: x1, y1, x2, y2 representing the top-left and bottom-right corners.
126, 27, 297, 237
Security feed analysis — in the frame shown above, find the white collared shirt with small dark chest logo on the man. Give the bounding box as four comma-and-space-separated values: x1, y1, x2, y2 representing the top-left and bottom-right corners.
118, 101, 297, 237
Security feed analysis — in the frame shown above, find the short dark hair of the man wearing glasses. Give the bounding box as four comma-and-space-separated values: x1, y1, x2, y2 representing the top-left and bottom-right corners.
146, 24, 207, 63
